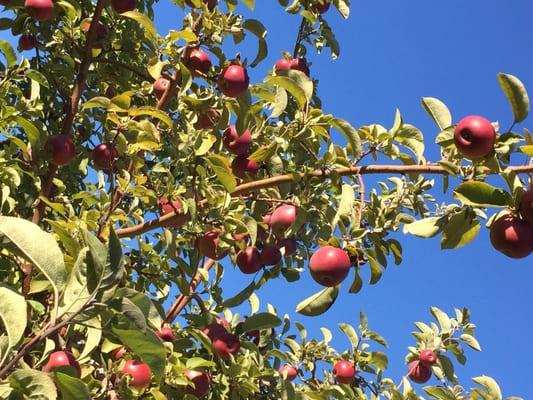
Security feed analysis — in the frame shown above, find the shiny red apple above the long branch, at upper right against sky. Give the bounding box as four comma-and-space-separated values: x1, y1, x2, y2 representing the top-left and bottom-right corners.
453, 115, 496, 158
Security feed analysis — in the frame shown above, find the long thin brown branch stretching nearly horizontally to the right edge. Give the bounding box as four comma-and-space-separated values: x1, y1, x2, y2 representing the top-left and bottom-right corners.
116, 164, 533, 237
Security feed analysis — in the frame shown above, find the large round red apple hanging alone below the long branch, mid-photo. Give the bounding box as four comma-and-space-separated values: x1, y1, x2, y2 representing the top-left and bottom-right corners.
309, 246, 352, 287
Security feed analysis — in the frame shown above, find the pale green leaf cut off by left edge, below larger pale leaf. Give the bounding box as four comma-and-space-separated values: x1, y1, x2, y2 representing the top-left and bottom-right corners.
0, 284, 27, 350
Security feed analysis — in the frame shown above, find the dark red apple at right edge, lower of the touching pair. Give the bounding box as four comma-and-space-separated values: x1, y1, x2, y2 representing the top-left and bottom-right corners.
490, 215, 533, 258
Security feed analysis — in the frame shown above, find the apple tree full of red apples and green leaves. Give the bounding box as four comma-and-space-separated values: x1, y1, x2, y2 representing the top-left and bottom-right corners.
0, 0, 533, 400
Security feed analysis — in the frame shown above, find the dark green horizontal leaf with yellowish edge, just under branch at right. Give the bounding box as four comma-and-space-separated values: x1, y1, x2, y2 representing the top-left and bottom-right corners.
453, 181, 513, 207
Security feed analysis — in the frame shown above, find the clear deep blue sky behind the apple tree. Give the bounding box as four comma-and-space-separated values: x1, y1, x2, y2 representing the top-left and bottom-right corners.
0, 0, 533, 399
